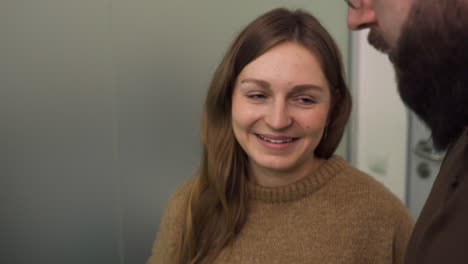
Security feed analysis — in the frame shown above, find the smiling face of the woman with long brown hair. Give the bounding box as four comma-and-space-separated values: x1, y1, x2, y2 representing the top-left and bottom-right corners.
232, 42, 331, 179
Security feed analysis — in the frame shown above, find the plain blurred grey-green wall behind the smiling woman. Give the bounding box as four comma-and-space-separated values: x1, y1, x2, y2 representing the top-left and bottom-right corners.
0, 0, 348, 264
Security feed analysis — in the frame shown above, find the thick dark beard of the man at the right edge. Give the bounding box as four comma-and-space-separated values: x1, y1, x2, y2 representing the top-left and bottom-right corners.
390, 0, 468, 151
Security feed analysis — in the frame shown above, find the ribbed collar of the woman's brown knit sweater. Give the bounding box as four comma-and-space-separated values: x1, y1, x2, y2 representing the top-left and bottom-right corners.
249, 156, 347, 203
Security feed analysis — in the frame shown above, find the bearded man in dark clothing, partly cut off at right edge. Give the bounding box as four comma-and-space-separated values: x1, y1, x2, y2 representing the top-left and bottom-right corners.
346, 0, 468, 264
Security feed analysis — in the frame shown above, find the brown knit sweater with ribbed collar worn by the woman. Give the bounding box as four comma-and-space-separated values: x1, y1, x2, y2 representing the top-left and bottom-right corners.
147, 156, 413, 264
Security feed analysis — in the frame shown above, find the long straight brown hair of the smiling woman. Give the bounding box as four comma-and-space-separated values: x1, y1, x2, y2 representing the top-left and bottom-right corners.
176, 8, 351, 264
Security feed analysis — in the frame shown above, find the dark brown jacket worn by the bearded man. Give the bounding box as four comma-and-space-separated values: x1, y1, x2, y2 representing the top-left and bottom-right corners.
405, 127, 468, 264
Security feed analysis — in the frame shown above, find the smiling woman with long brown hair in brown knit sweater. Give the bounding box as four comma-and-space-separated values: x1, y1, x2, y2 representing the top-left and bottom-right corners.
148, 9, 413, 264
